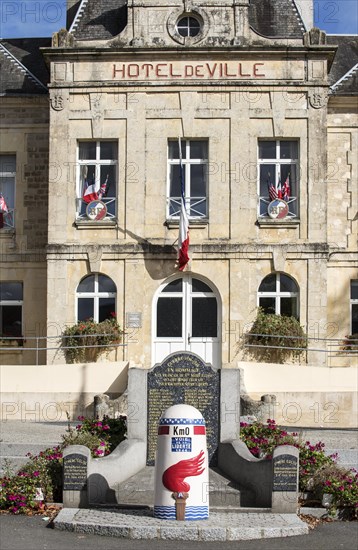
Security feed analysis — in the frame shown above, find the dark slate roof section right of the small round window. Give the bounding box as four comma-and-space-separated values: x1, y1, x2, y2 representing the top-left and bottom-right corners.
249, 0, 305, 38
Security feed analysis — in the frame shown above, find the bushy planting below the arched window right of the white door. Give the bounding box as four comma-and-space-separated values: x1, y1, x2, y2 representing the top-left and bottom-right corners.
241, 308, 307, 363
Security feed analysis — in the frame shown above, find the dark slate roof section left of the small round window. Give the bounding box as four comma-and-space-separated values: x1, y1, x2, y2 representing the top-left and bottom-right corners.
69, 0, 127, 40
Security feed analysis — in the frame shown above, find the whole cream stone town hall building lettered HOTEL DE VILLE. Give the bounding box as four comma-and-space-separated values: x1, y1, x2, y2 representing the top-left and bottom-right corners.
0, 0, 358, 392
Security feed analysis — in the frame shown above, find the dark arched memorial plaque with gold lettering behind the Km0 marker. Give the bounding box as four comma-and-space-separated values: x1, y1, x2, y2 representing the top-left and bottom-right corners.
147, 352, 220, 465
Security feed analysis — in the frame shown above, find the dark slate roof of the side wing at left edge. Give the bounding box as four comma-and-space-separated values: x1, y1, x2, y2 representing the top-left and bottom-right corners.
0, 38, 51, 95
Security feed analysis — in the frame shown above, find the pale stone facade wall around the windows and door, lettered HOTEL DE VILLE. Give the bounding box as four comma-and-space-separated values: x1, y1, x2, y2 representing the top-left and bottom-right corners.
0, 0, 358, 374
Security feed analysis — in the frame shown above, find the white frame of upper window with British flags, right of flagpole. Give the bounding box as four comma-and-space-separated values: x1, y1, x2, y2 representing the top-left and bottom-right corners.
257, 138, 300, 219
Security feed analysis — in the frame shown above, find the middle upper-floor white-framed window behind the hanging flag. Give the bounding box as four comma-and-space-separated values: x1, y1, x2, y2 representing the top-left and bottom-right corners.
167, 139, 208, 220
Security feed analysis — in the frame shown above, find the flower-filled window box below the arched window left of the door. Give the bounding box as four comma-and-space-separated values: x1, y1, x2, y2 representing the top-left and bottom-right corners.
61, 313, 123, 363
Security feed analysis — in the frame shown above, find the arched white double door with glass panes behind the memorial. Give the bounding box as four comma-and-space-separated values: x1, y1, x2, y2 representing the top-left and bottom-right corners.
153, 273, 221, 368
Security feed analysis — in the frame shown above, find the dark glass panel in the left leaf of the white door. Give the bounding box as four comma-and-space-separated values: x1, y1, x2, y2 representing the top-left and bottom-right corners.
157, 298, 183, 338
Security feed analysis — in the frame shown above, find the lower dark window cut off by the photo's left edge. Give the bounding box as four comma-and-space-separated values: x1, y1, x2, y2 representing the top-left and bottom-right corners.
0, 281, 23, 338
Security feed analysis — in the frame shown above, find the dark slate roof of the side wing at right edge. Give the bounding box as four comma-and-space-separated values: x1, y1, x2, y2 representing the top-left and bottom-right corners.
327, 35, 358, 95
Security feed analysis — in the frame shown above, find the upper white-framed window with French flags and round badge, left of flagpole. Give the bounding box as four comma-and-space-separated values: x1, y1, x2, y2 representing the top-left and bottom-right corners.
76, 141, 118, 221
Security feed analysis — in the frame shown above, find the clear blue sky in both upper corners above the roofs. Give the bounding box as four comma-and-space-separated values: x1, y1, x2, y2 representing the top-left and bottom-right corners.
0, 0, 358, 38
